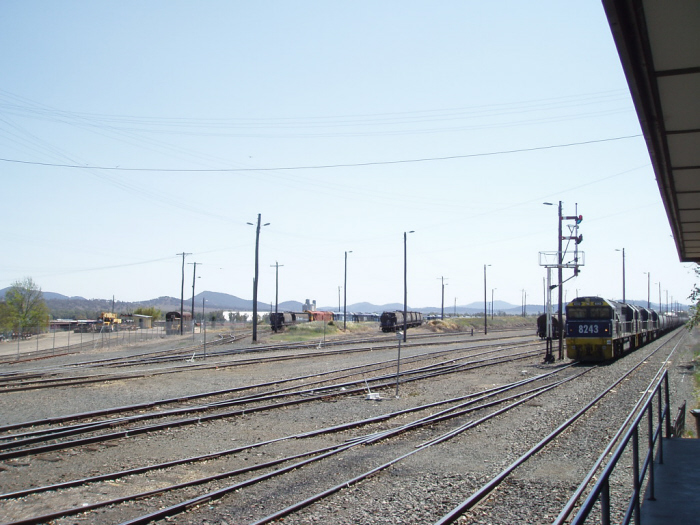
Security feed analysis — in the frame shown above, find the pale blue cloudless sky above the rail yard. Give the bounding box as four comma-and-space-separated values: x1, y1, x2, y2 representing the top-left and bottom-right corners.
0, 0, 695, 308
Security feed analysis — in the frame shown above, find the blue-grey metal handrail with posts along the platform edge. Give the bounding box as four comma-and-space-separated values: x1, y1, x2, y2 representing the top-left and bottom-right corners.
571, 370, 672, 525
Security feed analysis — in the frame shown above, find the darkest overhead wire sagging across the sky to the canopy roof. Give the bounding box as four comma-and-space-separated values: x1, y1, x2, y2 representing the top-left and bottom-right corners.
0, 134, 642, 173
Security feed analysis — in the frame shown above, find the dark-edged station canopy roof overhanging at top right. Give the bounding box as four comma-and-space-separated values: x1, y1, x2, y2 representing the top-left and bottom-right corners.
603, 0, 700, 263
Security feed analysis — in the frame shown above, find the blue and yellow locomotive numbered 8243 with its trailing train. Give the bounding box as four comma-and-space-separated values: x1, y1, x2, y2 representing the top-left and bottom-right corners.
565, 297, 688, 361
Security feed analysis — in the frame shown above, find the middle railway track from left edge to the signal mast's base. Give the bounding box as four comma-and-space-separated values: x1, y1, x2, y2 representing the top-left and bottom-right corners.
0, 343, 542, 461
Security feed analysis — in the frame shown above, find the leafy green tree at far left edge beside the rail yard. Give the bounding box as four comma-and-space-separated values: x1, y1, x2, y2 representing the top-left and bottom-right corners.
0, 277, 49, 333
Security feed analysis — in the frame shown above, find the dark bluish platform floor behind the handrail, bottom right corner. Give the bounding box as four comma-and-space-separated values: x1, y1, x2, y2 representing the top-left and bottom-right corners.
640, 438, 700, 525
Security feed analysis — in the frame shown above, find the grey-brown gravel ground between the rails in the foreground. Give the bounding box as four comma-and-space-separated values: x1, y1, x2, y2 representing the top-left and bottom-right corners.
0, 326, 698, 525
